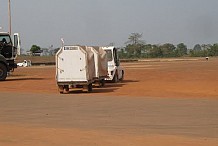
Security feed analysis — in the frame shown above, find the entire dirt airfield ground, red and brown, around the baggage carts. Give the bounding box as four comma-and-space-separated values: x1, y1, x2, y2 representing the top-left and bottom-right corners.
0, 58, 218, 146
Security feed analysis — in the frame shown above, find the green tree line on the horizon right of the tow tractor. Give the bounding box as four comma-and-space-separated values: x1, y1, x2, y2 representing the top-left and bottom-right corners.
119, 33, 218, 59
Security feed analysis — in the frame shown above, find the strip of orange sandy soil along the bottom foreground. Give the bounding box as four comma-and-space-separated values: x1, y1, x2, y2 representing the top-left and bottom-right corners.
0, 125, 218, 146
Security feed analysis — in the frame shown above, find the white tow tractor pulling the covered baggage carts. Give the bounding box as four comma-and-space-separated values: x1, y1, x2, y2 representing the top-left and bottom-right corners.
103, 46, 124, 83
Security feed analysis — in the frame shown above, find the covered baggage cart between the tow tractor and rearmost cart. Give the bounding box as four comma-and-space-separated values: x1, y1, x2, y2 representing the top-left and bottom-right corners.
88, 47, 108, 79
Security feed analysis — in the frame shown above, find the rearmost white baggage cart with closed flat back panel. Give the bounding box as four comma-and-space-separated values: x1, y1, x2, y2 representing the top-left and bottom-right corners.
56, 46, 95, 93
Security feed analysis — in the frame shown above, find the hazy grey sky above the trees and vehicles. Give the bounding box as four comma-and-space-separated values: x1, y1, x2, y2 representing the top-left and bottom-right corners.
0, 0, 218, 50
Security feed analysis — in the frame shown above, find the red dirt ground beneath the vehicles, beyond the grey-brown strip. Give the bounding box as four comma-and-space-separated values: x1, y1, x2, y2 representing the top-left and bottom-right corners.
0, 58, 218, 98
